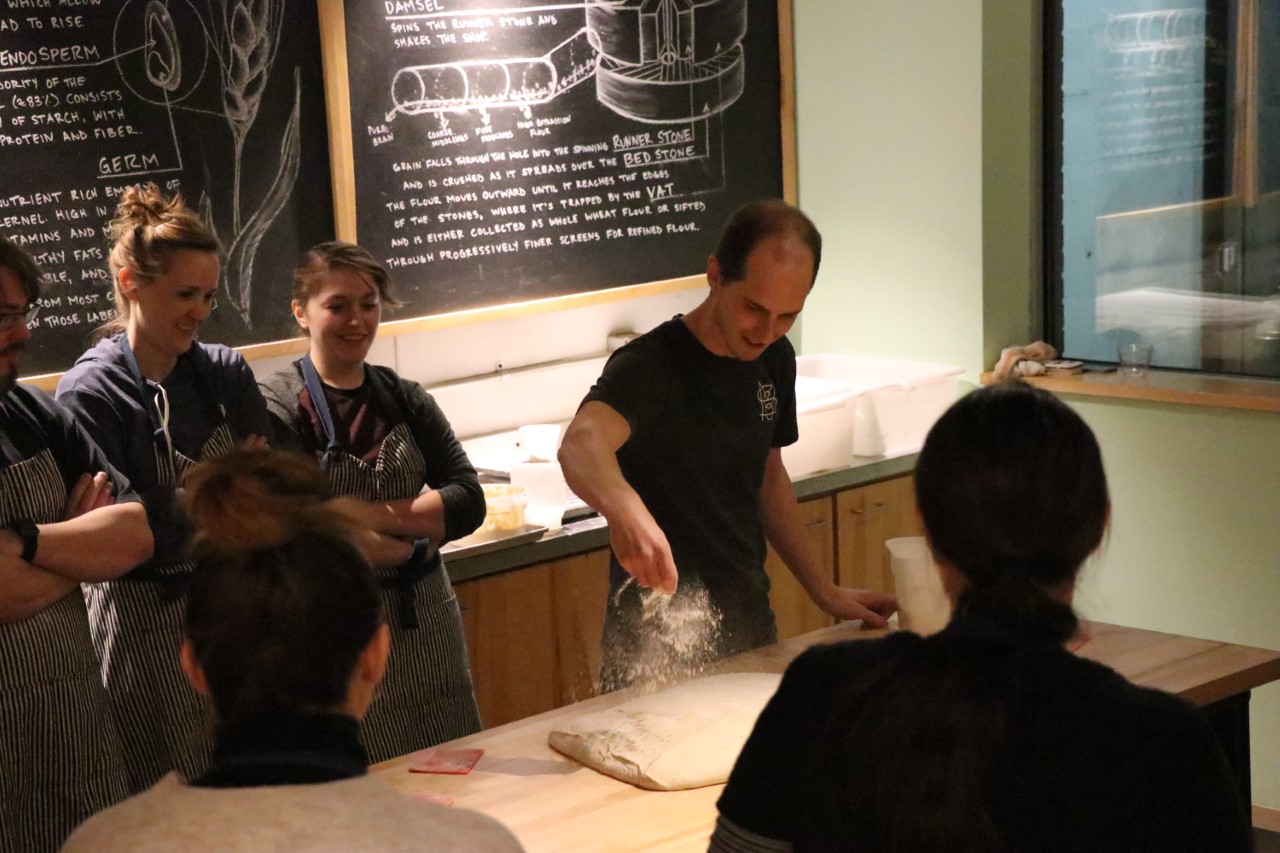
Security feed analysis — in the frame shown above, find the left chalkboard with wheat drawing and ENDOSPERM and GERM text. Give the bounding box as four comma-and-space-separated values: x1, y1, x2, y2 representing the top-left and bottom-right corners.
0, 0, 334, 375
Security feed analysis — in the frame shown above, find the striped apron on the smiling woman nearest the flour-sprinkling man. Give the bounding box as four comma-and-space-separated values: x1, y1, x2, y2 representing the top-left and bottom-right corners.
302, 355, 480, 762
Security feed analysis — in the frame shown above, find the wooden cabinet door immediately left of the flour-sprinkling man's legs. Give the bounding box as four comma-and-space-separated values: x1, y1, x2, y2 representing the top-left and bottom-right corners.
549, 549, 609, 704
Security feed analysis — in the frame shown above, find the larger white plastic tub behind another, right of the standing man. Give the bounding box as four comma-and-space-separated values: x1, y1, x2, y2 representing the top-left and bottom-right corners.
796, 353, 964, 456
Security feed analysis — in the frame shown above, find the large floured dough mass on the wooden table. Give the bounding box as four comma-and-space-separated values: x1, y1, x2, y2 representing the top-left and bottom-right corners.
547, 672, 782, 790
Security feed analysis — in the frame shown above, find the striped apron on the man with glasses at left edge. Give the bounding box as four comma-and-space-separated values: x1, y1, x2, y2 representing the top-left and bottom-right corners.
0, 450, 128, 852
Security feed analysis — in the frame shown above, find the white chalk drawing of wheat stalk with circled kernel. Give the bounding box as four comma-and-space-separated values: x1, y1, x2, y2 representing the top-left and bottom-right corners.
113, 0, 302, 328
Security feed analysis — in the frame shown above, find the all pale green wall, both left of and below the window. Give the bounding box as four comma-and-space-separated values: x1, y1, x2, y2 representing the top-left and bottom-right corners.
795, 0, 1280, 808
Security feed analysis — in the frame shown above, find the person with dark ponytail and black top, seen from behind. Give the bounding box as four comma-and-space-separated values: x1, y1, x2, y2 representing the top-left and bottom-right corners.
710, 383, 1251, 853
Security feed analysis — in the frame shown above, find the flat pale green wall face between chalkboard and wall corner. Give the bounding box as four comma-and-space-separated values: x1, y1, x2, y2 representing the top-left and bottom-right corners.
795, 0, 983, 369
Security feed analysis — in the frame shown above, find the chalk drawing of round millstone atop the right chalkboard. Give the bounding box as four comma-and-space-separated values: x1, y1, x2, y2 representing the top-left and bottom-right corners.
586, 0, 746, 124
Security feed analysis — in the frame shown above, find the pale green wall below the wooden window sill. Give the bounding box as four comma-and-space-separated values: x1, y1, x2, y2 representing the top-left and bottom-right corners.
1071, 397, 1280, 808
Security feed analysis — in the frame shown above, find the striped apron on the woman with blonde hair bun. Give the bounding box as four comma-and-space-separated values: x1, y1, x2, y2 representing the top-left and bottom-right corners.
84, 341, 236, 793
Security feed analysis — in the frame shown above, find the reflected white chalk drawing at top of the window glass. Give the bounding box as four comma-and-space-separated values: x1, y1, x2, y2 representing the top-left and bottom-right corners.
1102, 9, 1212, 76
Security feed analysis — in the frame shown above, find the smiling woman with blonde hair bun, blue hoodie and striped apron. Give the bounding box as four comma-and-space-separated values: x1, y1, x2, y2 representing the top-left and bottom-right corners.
58, 184, 268, 792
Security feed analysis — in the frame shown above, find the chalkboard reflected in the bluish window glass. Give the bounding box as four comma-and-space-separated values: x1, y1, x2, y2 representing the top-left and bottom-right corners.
1062, 0, 1236, 215
